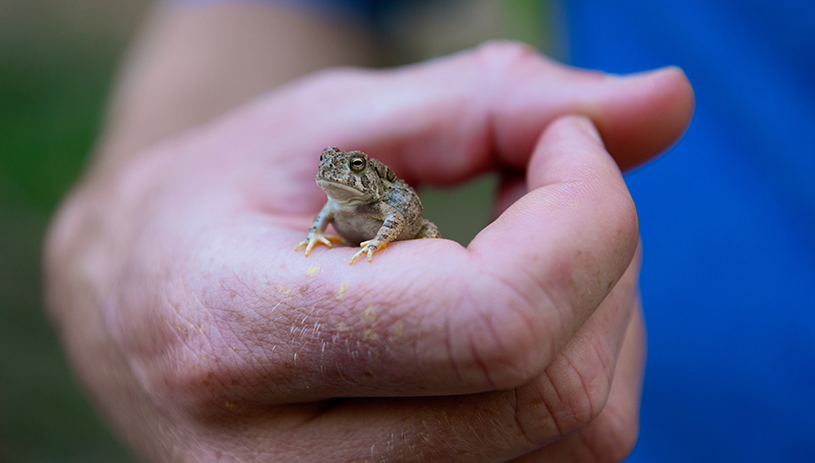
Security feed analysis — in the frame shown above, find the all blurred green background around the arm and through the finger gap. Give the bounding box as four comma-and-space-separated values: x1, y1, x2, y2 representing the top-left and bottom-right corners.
0, 0, 543, 463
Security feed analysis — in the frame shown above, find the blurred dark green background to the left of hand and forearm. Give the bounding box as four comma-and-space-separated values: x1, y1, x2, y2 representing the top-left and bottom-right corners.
0, 0, 145, 463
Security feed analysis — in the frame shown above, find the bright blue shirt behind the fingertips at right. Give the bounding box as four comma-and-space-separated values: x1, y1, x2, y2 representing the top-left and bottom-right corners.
564, 0, 815, 462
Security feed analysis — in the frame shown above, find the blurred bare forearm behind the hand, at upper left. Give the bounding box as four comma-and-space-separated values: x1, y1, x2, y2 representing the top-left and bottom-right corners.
99, 2, 374, 174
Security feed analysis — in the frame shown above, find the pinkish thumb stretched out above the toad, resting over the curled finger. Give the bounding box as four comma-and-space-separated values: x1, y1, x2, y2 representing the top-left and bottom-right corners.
247, 42, 693, 184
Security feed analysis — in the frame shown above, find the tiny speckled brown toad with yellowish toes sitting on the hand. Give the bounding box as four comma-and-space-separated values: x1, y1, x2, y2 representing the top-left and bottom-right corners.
294, 147, 441, 265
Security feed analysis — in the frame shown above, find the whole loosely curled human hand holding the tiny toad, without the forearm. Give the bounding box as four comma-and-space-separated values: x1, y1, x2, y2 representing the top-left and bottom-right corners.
47, 44, 692, 462
